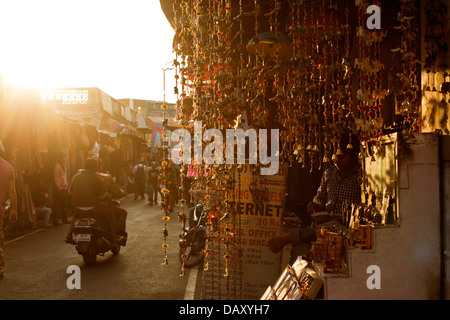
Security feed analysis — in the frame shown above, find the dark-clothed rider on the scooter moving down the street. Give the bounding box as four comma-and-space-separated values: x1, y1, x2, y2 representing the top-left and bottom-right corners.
66, 159, 127, 242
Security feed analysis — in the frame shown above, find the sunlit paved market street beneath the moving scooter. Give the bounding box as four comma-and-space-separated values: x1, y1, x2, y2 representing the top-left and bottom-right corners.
0, 196, 201, 300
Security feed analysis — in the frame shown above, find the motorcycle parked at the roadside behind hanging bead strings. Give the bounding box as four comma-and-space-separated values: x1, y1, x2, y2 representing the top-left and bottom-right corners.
179, 204, 207, 268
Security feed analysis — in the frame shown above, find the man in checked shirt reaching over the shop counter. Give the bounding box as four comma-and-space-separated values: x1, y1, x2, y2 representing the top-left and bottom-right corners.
267, 134, 361, 258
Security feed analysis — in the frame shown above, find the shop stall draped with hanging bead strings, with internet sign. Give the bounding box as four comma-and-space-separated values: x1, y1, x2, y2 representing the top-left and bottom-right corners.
160, 0, 450, 299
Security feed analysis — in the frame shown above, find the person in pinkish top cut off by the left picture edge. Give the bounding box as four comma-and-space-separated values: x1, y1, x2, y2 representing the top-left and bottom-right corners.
0, 140, 19, 280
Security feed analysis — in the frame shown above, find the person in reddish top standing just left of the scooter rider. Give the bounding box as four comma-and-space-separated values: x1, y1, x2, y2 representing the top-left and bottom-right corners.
52, 153, 69, 226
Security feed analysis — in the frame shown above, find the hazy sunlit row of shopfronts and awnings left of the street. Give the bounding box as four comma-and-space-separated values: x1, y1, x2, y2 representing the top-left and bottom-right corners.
0, 87, 143, 232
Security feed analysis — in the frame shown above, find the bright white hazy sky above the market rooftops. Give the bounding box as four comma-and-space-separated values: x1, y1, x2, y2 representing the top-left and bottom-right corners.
0, 0, 176, 102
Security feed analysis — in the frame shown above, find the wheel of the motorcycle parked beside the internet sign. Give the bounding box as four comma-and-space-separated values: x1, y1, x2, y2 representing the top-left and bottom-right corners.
179, 230, 206, 268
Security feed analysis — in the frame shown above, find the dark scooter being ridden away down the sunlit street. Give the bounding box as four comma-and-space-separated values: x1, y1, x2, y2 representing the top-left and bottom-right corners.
72, 201, 127, 266
